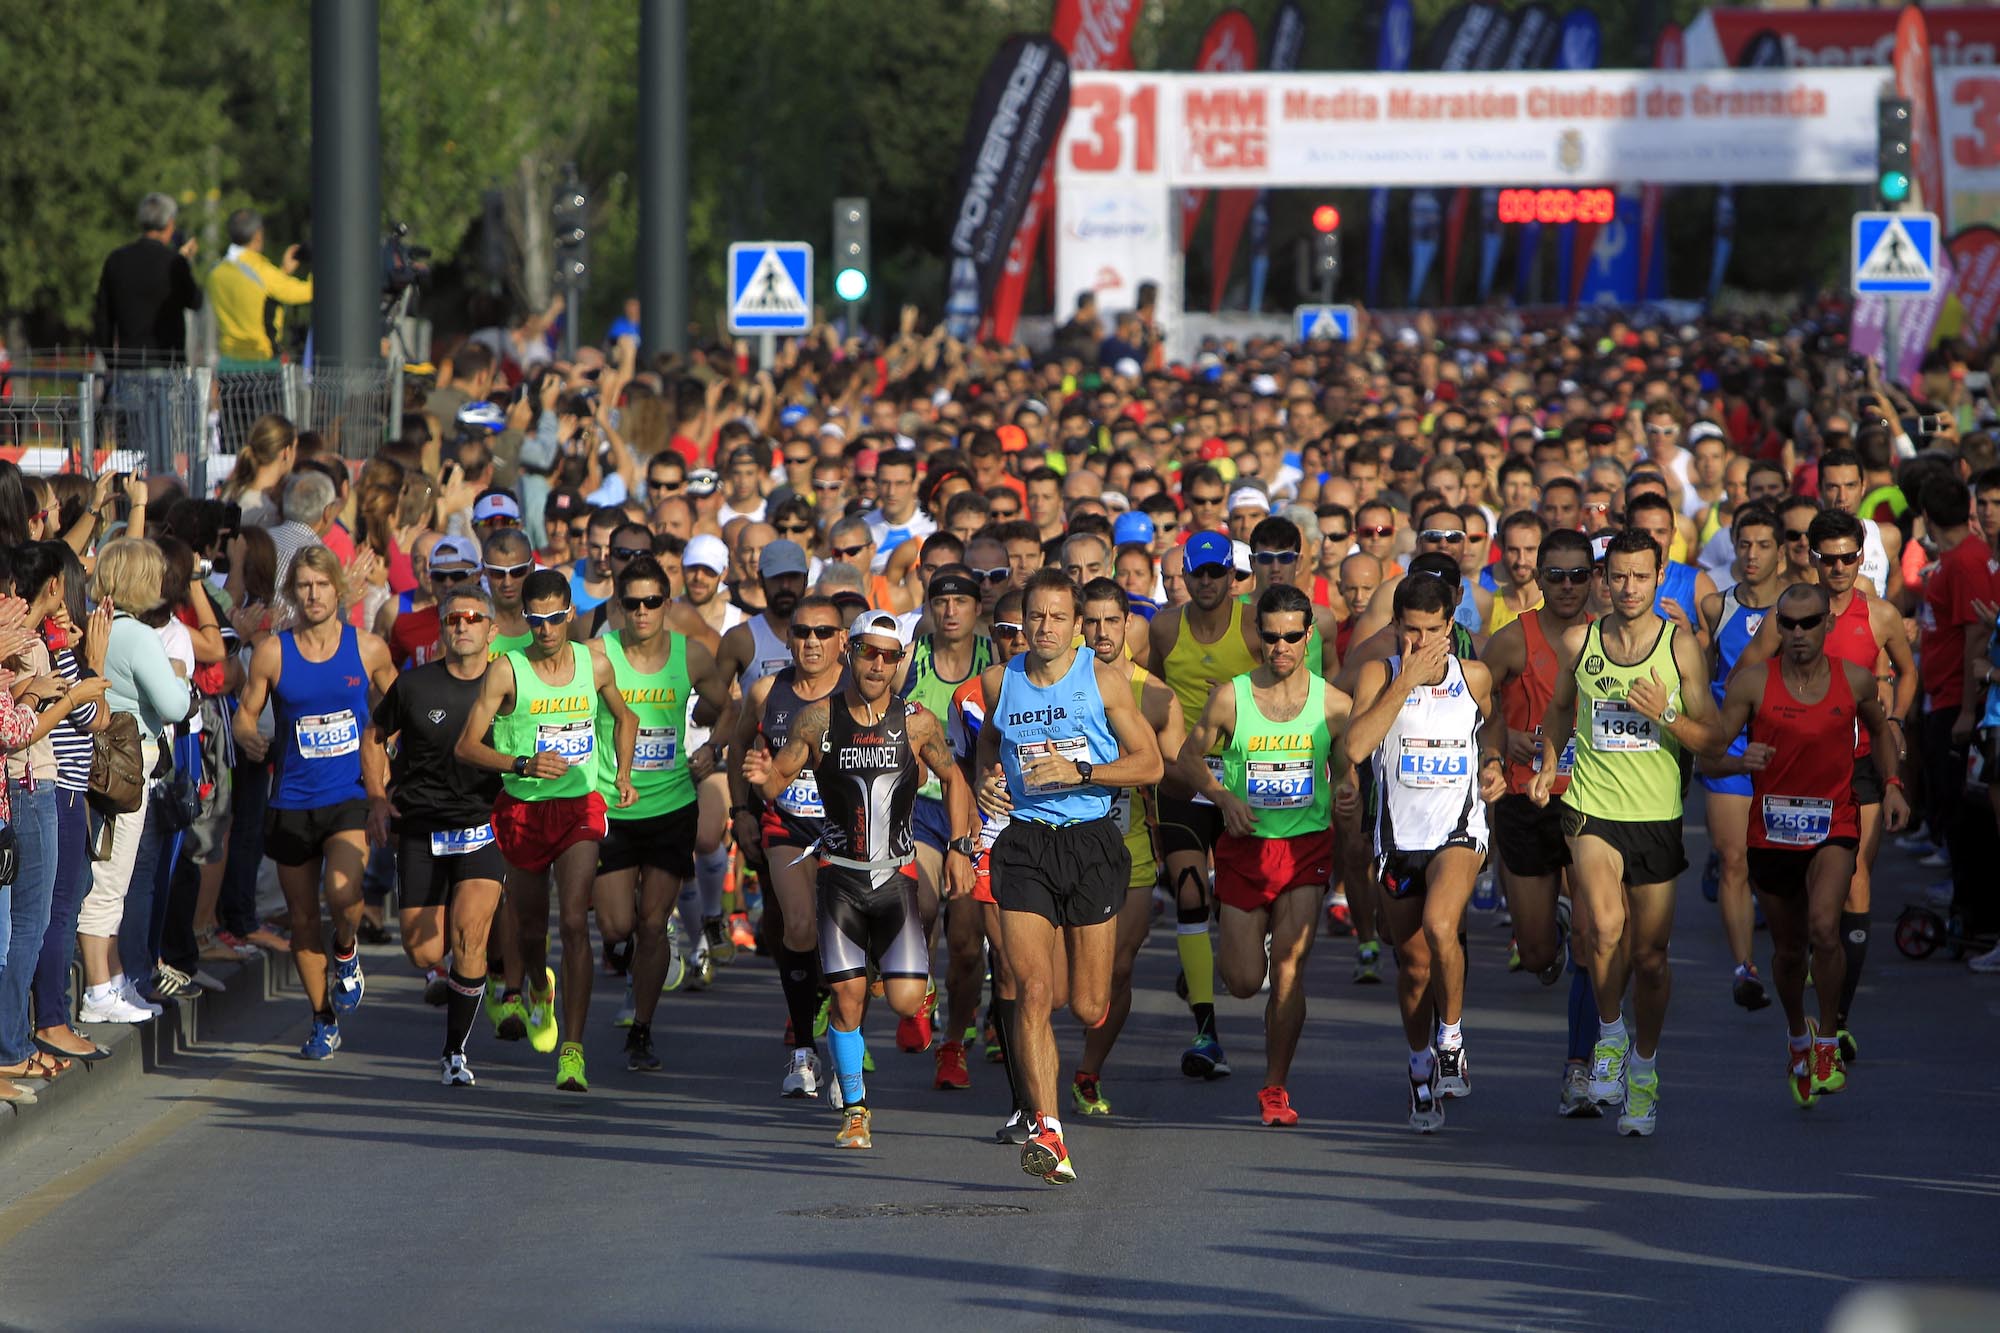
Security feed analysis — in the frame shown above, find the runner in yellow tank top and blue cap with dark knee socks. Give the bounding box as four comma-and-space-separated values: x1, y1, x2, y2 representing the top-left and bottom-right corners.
1146, 524, 1262, 1079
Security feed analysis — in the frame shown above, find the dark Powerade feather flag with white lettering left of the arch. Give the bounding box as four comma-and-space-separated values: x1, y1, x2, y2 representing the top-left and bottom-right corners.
944, 36, 1070, 338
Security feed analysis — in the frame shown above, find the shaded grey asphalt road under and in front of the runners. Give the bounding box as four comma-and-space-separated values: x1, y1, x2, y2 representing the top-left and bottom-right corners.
0, 824, 2000, 1329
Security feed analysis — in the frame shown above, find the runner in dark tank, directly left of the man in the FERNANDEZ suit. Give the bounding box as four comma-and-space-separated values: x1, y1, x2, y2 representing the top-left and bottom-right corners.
728, 592, 846, 1097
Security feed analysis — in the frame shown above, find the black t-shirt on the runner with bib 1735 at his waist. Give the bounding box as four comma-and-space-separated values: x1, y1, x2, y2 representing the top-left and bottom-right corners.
374, 662, 500, 835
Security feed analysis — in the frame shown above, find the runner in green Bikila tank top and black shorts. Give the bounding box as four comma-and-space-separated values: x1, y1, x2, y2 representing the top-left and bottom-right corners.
592, 554, 730, 1073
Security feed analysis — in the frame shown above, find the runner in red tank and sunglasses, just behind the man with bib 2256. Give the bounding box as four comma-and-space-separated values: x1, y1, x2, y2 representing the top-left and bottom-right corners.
1738, 508, 1918, 1065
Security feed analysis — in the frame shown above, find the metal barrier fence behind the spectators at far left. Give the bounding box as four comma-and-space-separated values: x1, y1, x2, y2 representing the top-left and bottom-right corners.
0, 352, 402, 494
